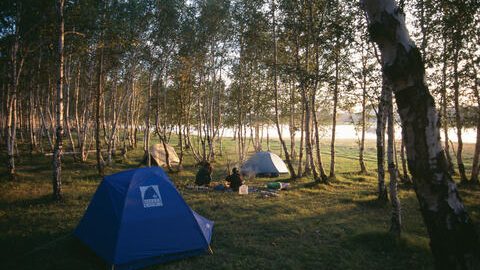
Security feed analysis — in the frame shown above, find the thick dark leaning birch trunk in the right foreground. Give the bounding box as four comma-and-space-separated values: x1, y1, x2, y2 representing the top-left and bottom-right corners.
361, 0, 480, 269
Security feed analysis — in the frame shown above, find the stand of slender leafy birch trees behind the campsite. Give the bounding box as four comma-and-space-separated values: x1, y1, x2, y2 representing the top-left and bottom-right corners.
0, 0, 480, 265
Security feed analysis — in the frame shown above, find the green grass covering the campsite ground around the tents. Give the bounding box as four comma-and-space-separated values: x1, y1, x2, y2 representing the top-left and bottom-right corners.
0, 139, 480, 269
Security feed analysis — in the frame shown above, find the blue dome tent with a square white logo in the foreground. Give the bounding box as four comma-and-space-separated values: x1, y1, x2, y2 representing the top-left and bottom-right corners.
74, 167, 213, 269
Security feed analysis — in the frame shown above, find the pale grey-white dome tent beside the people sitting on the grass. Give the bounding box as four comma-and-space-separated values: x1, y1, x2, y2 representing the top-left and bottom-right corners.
240, 152, 289, 177
